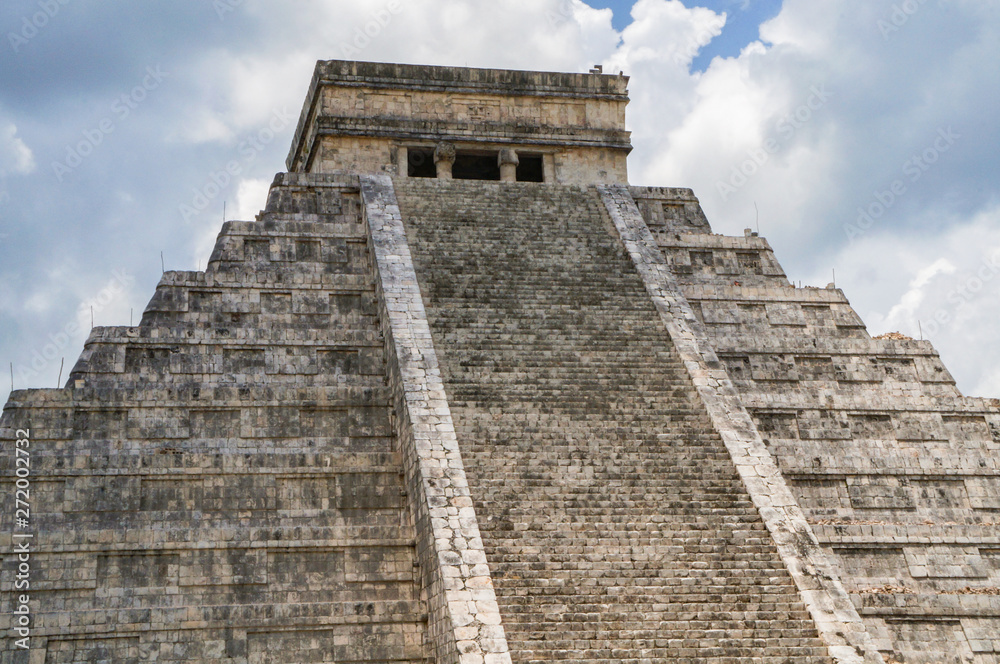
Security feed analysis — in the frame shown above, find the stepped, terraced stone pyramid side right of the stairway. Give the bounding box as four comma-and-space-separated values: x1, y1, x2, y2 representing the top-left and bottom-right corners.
632, 188, 1000, 664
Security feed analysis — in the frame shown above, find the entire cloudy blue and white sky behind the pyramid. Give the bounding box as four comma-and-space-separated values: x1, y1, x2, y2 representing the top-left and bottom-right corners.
0, 0, 1000, 401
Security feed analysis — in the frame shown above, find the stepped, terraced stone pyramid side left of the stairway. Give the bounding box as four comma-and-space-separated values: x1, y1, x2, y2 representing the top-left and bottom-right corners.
0, 175, 433, 664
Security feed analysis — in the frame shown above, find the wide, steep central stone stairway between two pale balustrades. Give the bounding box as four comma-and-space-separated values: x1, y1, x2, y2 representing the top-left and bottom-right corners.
395, 179, 831, 664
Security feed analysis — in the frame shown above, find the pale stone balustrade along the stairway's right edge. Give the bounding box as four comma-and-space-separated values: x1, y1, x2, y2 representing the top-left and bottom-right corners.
597, 185, 884, 664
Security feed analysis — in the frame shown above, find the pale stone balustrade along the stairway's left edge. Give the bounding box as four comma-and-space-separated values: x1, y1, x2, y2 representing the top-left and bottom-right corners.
361, 175, 511, 664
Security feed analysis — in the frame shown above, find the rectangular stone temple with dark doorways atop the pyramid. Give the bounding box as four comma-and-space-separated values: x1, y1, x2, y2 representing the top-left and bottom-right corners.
286, 60, 632, 184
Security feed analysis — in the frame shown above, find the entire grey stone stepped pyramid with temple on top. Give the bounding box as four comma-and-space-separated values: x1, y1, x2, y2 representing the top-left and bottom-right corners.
0, 61, 1000, 664
